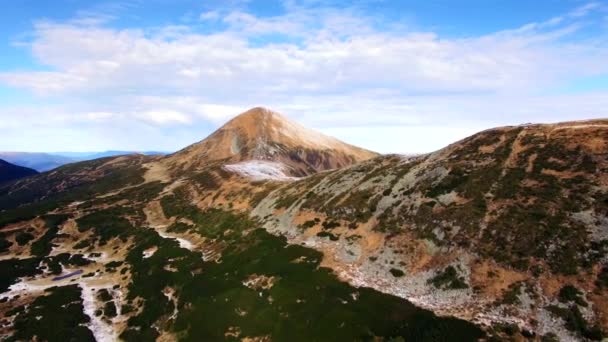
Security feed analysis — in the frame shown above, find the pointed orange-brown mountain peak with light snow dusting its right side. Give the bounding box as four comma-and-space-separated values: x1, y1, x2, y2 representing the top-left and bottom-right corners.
166, 108, 377, 176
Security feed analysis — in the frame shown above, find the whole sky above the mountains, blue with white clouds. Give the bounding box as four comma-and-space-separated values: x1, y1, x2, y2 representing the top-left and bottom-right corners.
0, 0, 608, 153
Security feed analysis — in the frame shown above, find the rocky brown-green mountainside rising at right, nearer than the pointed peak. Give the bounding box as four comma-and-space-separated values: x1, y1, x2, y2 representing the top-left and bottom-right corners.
254, 121, 608, 339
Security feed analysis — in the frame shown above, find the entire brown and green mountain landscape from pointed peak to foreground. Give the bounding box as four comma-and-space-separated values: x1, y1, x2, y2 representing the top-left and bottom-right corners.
0, 108, 608, 341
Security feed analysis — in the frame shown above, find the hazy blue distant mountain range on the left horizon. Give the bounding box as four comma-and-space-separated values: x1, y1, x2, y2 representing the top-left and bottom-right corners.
0, 151, 166, 172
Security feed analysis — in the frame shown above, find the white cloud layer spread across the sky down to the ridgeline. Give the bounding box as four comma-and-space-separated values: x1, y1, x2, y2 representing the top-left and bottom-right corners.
0, 3, 608, 152
